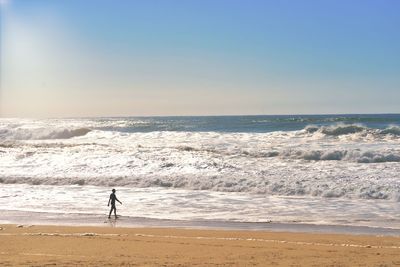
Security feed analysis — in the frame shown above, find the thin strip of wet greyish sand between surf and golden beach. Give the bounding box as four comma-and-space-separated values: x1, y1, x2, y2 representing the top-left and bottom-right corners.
0, 211, 400, 237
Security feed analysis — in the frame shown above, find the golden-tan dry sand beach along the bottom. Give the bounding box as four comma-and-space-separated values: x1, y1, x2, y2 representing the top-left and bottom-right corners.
0, 225, 400, 266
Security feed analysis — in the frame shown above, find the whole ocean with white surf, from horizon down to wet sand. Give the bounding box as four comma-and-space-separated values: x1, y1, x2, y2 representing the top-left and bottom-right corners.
0, 114, 400, 232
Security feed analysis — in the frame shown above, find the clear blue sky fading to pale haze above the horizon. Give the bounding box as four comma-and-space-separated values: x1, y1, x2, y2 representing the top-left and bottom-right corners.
0, 0, 400, 117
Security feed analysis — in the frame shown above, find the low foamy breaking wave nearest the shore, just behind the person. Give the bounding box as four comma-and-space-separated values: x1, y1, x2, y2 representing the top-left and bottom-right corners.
0, 172, 400, 202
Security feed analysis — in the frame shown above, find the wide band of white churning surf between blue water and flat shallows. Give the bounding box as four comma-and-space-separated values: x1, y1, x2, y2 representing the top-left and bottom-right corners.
0, 120, 400, 201
